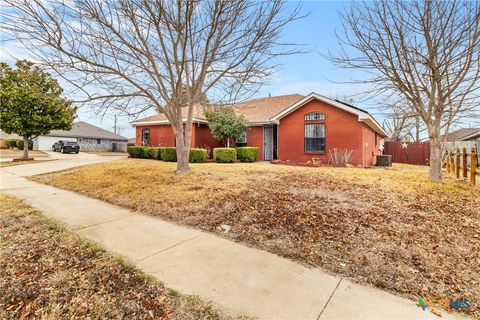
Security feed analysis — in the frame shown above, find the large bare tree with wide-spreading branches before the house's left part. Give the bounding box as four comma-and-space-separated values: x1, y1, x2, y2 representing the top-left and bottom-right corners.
2, 0, 299, 173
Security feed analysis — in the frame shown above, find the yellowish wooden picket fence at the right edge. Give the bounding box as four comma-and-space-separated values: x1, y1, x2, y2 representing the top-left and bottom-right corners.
445, 148, 480, 186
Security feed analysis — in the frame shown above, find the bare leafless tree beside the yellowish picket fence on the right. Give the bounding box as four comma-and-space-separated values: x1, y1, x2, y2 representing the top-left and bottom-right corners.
329, 0, 480, 182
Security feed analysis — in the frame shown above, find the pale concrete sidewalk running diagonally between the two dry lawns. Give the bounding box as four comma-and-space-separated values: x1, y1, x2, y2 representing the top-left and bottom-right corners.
0, 161, 459, 319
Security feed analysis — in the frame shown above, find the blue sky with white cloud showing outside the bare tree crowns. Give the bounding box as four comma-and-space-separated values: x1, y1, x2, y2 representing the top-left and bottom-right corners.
0, 1, 478, 138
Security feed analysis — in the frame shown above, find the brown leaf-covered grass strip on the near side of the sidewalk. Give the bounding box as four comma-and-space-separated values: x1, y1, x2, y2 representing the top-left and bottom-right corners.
0, 194, 246, 319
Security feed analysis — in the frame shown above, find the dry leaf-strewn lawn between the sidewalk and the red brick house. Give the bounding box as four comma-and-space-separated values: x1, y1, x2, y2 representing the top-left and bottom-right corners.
34, 159, 480, 317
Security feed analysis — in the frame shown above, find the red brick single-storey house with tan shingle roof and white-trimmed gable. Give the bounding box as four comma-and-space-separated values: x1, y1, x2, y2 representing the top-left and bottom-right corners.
131, 93, 387, 166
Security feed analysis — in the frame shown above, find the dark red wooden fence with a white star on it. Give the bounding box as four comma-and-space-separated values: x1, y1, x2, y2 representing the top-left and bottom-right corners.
383, 141, 430, 165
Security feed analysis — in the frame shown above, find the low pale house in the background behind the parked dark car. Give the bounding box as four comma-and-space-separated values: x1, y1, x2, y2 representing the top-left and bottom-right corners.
33, 121, 128, 152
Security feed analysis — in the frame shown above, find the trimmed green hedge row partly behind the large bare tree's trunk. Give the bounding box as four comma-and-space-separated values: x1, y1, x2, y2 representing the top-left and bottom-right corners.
127, 146, 207, 163
